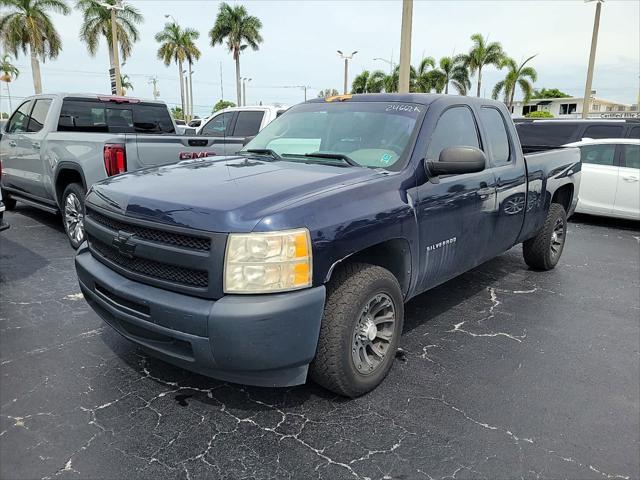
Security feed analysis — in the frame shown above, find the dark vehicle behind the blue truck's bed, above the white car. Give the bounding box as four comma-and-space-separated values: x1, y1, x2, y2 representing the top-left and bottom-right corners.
515, 118, 640, 153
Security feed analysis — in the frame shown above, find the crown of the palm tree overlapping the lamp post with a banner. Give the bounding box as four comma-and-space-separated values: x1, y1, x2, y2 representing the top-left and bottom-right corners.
76, 0, 143, 73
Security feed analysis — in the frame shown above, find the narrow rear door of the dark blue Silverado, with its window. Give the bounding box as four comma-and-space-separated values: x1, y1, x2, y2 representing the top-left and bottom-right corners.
480, 106, 527, 257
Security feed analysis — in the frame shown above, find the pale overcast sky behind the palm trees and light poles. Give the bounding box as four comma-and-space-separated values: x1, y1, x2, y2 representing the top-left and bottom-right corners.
0, 0, 640, 116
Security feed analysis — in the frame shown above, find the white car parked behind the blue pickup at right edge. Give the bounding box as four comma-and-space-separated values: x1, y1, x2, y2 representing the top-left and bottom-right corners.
566, 138, 640, 220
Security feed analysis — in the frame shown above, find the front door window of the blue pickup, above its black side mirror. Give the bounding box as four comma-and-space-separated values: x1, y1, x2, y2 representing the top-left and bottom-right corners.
427, 107, 480, 161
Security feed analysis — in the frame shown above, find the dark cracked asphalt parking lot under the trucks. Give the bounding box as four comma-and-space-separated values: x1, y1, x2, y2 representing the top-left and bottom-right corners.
0, 206, 640, 479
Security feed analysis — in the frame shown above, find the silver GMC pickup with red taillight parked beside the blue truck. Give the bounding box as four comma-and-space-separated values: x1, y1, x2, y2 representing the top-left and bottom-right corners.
0, 94, 222, 248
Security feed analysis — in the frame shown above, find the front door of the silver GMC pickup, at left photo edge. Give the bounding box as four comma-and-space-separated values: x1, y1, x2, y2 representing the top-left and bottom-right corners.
0, 100, 33, 195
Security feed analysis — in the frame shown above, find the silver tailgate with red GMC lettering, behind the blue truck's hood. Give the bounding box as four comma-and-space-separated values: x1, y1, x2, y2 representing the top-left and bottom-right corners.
132, 134, 224, 168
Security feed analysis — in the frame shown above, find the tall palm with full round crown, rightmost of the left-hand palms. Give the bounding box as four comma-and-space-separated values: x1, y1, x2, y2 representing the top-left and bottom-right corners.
209, 2, 262, 105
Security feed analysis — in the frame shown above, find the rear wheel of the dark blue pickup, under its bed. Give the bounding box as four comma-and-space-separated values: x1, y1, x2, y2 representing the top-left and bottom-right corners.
522, 203, 567, 270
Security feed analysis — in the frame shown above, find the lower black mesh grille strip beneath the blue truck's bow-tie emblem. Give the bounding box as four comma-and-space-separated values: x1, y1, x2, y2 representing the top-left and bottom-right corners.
89, 237, 209, 288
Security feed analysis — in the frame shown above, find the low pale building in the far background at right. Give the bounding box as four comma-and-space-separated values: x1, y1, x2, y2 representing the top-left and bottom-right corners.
511, 97, 640, 118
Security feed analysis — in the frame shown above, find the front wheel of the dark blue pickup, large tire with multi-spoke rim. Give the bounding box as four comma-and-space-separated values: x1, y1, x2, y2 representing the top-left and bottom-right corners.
310, 263, 404, 398
